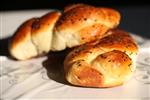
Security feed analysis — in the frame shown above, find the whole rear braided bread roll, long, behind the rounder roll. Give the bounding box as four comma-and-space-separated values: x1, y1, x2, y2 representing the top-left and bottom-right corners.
9, 4, 120, 60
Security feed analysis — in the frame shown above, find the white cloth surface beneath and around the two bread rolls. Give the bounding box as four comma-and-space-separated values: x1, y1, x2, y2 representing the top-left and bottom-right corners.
0, 10, 150, 100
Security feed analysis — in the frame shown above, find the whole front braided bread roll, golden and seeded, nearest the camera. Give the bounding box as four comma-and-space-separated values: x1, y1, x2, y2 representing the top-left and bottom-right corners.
64, 29, 137, 87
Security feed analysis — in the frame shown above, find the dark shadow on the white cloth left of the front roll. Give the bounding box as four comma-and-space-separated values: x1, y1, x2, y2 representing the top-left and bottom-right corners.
42, 49, 70, 85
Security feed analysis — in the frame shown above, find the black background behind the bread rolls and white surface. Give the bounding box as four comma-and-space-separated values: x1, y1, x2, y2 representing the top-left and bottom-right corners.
0, 0, 150, 55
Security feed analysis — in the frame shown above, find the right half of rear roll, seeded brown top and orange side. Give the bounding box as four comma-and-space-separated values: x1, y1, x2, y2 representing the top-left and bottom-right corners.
51, 4, 120, 51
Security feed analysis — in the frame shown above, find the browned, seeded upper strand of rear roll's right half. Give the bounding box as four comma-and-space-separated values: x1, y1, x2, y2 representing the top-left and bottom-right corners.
56, 5, 120, 31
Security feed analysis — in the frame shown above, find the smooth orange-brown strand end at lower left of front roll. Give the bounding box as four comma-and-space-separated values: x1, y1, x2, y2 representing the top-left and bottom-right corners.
72, 66, 103, 87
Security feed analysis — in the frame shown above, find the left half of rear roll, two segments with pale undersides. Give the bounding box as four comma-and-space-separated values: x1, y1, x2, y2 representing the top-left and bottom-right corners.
9, 11, 61, 60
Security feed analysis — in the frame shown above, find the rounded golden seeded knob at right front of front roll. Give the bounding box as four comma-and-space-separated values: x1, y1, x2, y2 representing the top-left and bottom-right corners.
92, 50, 133, 87
